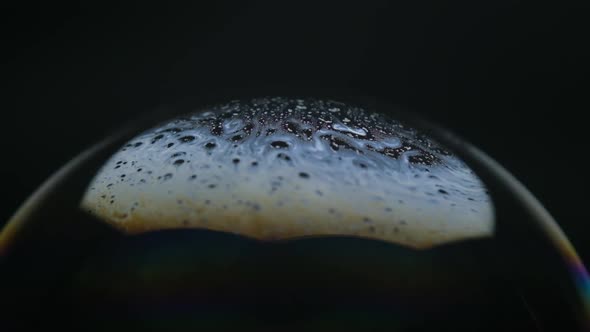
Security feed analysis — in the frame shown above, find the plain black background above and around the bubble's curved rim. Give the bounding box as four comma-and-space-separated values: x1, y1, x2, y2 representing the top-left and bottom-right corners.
0, 1, 590, 262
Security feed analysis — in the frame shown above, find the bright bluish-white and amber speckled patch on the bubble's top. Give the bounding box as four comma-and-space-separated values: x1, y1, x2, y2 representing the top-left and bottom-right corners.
82, 98, 494, 248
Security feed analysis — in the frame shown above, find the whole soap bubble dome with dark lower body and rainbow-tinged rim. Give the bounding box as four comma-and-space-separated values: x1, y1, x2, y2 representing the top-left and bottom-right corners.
0, 97, 590, 331
